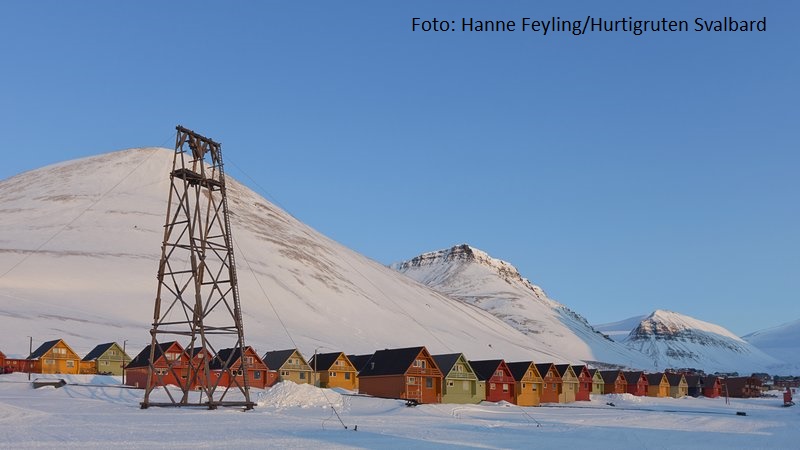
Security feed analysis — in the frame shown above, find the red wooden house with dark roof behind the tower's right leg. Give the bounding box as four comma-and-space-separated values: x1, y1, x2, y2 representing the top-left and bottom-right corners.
208, 345, 278, 389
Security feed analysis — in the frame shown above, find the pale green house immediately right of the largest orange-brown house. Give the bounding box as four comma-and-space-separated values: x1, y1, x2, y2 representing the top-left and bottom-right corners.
433, 353, 486, 404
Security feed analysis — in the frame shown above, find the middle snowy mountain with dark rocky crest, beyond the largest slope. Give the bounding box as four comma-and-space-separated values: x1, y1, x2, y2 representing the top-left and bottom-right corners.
393, 244, 651, 367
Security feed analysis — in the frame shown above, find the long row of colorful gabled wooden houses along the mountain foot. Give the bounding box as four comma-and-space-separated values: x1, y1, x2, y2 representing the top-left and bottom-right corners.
0, 340, 761, 406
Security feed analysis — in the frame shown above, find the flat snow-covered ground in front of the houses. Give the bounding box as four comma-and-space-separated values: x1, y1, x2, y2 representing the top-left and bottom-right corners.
0, 374, 800, 449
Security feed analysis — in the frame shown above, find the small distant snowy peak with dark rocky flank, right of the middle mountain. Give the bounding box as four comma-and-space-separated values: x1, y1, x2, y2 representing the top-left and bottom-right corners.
623, 310, 781, 374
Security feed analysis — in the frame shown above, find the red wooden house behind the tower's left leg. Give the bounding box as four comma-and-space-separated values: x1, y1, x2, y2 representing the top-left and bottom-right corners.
125, 341, 189, 389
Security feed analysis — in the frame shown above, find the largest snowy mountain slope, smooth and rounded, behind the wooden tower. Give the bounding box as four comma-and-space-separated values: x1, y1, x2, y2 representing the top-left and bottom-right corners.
0, 148, 604, 361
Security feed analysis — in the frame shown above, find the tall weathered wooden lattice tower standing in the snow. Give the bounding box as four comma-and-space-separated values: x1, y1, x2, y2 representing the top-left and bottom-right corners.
141, 125, 254, 409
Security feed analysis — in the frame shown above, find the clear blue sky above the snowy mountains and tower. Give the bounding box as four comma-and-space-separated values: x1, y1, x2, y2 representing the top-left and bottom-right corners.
0, 1, 800, 334
